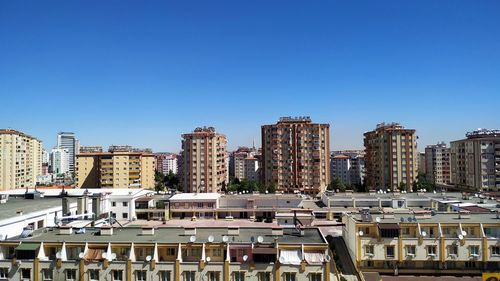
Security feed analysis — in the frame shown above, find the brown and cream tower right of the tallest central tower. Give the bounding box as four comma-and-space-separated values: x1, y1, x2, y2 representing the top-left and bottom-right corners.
364, 123, 418, 190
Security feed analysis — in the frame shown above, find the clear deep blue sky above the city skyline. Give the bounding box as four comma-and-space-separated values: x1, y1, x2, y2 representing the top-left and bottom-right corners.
0, 0, 500, 151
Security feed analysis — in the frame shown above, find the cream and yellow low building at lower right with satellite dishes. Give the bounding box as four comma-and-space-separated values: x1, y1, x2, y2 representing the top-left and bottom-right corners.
343, 211, 500, 276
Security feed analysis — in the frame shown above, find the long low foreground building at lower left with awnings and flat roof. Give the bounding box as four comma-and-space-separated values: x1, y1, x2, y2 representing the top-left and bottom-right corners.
0, 226, 339, 281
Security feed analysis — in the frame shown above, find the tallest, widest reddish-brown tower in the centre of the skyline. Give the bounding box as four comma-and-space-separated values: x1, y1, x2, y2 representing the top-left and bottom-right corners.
262, 117, 330, 194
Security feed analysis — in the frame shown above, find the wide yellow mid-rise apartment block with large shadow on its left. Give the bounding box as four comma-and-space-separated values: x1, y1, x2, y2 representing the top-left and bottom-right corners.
76, 146, 156, 188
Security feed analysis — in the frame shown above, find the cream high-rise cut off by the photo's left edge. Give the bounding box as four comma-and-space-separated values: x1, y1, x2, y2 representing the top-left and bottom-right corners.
0, 129, 42, 190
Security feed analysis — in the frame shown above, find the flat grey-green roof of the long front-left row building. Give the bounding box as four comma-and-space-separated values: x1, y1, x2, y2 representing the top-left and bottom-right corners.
12, 224, 326, 244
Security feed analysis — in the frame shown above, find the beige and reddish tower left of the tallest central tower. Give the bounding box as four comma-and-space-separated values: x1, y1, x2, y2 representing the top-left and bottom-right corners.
182, 127, 228, 192
